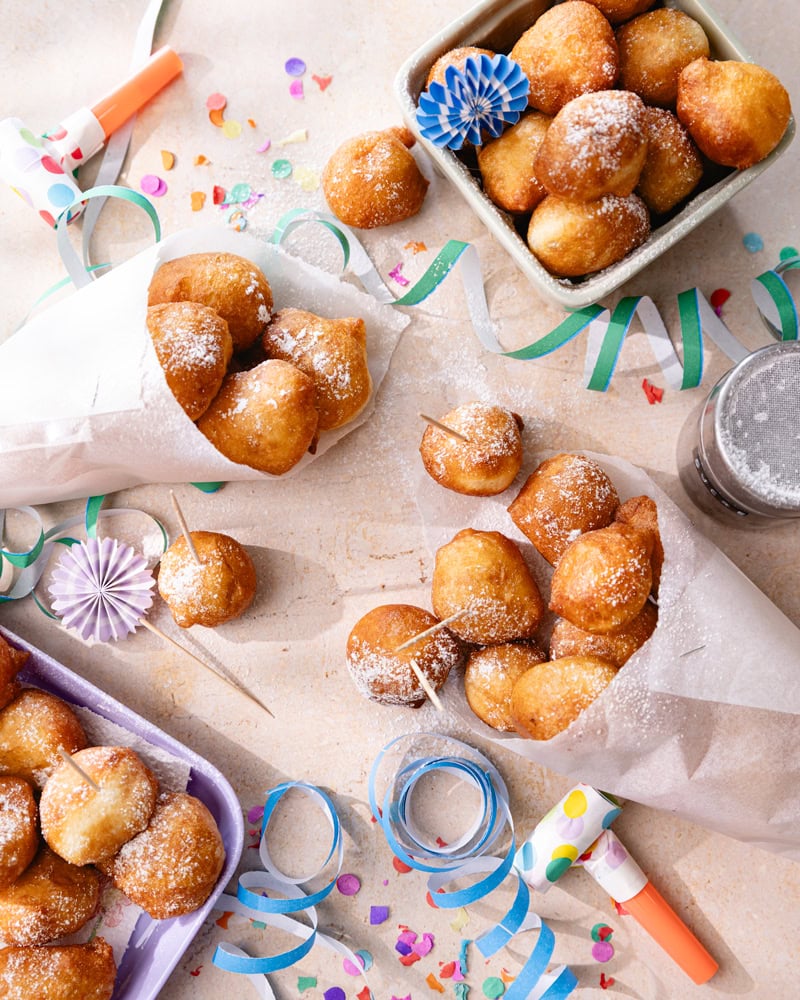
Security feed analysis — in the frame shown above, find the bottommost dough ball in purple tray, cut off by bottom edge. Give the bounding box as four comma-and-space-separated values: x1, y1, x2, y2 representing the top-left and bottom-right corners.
0, 937, 117, 1000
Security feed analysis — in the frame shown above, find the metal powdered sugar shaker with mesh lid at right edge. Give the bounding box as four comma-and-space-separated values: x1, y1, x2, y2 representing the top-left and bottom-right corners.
703, 341, 800, 517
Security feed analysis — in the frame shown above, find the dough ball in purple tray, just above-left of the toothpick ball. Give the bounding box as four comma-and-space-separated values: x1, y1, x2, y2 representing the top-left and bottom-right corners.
0, 688, 88, 788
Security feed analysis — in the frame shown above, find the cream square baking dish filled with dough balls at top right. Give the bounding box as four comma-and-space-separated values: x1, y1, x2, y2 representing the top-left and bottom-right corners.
395, 0, 795, 309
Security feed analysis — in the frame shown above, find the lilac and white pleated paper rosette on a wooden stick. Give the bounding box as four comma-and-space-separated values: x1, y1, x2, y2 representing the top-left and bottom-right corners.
49, 538, 155, 642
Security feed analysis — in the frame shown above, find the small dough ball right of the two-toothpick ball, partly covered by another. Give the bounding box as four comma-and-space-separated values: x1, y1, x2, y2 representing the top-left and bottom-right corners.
464, 642, 547, 733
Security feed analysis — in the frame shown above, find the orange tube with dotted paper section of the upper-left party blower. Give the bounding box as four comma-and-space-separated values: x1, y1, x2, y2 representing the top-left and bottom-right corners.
44, 45, 183, 171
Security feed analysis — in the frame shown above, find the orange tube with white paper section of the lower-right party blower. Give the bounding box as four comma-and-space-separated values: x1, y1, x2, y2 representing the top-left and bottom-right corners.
580, 830, 719, 985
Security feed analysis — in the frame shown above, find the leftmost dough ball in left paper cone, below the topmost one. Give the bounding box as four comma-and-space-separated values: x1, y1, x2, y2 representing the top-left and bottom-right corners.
147, 302, 233, 420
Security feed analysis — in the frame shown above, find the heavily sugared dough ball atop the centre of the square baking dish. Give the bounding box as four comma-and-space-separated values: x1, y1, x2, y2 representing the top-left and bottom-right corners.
534, 90, 647, 201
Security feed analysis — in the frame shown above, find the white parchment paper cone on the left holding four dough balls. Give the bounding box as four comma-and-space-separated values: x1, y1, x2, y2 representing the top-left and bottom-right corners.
0, 227, 408, 507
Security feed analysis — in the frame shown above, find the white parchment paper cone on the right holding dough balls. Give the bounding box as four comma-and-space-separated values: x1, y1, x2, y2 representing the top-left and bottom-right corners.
417, 452, 800, 858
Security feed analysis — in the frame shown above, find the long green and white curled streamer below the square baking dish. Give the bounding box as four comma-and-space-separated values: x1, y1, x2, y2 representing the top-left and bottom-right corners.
271, 209, 800, 392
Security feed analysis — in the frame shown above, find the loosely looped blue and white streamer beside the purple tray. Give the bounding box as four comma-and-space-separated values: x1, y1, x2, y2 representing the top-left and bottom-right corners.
211, 781, 376, 1000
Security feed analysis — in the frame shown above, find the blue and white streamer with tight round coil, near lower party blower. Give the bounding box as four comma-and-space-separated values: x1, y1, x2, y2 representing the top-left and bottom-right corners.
368, 733, 578, 1000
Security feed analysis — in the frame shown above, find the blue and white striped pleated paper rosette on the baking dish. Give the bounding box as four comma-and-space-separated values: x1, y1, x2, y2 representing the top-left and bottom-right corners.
417, 55, 530, 149
